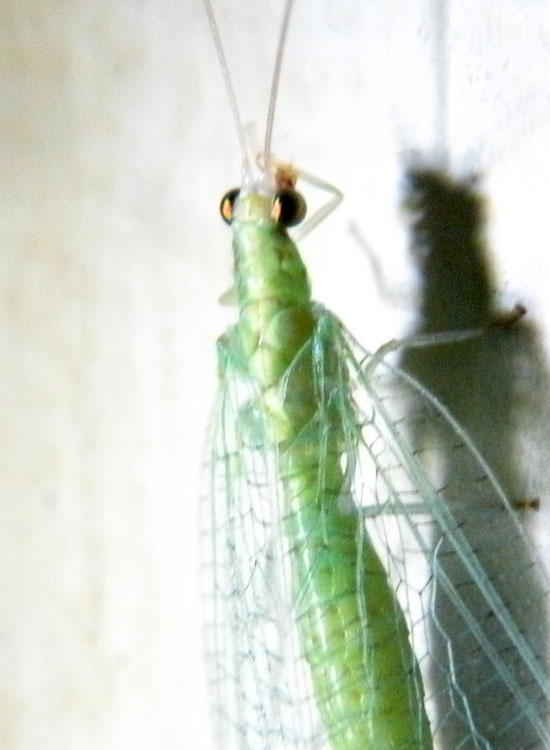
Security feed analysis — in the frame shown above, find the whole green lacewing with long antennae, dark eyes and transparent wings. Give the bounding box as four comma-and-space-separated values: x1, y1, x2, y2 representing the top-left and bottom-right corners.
204, 0, 550, 750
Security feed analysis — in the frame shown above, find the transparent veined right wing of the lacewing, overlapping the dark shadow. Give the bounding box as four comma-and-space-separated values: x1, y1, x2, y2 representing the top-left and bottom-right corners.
350, 318, 550, 750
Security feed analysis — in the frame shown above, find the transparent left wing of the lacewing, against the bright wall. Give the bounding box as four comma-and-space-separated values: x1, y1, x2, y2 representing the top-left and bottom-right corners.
203, 336, 328, 750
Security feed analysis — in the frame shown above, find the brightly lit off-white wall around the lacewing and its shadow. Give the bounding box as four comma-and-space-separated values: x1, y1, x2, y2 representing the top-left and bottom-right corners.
0, 0, 550, 750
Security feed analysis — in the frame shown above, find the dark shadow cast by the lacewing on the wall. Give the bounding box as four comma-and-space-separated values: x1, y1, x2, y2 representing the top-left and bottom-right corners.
400, 164, 550, 750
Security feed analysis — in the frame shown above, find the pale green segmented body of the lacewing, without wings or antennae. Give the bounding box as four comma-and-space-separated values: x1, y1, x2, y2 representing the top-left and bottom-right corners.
226, 195, 432, 750
